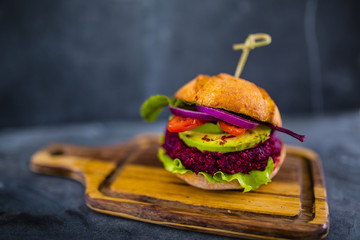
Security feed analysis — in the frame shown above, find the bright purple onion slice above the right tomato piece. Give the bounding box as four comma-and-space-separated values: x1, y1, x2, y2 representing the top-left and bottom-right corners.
196, 106, 259, 129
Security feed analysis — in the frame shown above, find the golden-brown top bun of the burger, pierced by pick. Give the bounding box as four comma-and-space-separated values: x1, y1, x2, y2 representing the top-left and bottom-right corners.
175, 73, 282, 127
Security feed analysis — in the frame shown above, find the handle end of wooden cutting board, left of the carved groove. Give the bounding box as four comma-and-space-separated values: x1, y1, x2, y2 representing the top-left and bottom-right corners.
30, 133, 157, 186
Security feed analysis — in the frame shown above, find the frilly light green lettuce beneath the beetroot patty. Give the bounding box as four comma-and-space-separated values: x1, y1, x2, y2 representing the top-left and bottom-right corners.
158, 147, 274, 192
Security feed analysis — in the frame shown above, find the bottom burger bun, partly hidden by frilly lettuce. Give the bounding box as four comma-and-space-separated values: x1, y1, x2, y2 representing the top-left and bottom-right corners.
176, 145, 286, 190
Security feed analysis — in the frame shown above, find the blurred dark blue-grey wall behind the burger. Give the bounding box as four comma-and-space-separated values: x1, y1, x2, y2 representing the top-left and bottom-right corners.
0, 0, 360, 128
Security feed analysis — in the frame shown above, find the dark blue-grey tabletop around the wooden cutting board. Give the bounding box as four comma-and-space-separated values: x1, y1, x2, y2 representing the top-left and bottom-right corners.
0, 112, 360, 240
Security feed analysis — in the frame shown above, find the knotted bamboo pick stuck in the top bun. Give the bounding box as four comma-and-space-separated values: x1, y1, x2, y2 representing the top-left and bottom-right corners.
233, 33, 271, 78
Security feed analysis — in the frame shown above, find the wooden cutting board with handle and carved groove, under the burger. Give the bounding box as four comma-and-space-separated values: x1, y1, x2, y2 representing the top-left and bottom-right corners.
30, 134, 329, 239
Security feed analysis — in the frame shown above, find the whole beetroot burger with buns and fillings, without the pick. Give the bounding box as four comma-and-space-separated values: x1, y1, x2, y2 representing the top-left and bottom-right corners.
141, 73, 304, 192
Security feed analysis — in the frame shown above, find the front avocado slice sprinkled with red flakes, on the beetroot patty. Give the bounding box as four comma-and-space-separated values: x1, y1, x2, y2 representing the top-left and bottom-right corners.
179, 125, 271, 153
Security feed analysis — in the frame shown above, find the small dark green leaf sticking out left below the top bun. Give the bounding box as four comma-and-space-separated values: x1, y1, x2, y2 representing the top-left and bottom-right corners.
140, 95, 186, 122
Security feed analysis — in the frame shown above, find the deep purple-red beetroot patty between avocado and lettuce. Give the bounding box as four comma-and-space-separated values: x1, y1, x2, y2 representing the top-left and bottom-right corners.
162, 131, 282, 175
